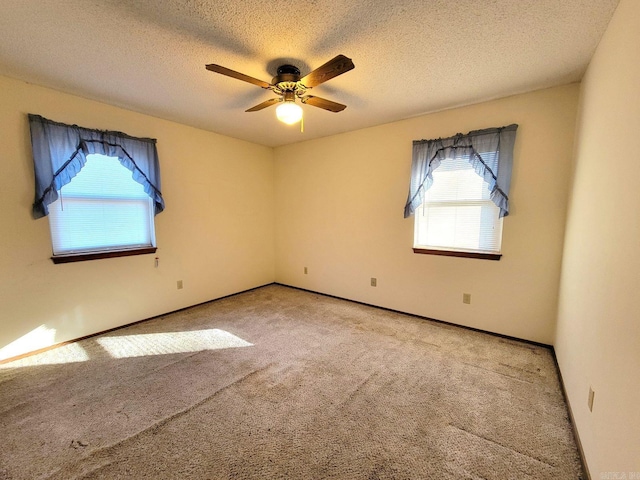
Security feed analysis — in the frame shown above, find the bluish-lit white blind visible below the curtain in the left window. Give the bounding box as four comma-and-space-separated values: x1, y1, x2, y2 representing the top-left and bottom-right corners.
49, 154, 155, 255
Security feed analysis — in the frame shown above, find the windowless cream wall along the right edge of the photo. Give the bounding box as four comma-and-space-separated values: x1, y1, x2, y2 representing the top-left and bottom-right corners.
555, 0, 640, 479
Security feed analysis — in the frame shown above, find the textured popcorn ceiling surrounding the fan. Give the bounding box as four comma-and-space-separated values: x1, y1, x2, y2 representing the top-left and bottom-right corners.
0, 0, 618, 146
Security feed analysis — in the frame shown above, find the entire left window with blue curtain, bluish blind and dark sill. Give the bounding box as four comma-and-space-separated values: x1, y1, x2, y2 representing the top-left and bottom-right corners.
29, 114, 164, 263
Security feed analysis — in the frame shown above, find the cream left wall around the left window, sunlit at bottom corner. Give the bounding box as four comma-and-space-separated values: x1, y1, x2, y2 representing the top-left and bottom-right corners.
0, 77, 274, 359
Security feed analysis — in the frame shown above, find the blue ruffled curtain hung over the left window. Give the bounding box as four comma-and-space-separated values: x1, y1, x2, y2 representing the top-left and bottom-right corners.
29, 114, 164, 218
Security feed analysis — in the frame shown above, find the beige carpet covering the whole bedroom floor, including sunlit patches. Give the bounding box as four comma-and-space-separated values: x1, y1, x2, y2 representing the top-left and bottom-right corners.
0, 285, 581, 480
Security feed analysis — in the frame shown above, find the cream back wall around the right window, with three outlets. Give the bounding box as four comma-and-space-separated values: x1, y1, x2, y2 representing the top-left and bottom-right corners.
275, 84, 579, 344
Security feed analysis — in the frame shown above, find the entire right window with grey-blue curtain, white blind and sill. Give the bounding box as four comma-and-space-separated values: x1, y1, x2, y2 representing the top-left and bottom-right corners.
404, 124, 518, 260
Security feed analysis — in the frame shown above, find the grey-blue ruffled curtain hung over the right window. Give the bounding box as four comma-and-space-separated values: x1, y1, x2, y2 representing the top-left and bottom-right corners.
404, 124, 518, 218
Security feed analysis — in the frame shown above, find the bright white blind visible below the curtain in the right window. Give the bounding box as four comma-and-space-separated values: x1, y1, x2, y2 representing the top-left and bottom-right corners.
414, 159, 502, 253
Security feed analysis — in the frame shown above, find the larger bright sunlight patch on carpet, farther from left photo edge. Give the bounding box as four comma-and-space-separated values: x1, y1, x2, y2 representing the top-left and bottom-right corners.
96, 328, 253, 358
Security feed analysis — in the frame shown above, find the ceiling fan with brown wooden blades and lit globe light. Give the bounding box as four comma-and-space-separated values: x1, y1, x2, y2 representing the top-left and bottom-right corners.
206, 55, 355, 124
